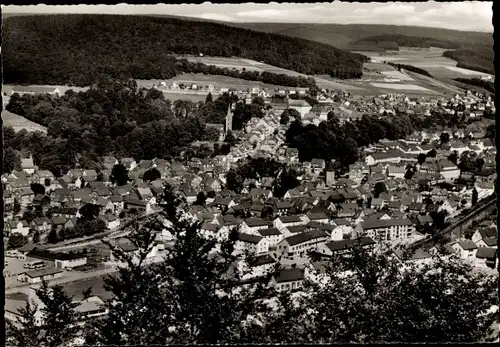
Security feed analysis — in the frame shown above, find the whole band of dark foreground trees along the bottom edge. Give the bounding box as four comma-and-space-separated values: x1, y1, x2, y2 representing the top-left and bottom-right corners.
6, 192, 498, 347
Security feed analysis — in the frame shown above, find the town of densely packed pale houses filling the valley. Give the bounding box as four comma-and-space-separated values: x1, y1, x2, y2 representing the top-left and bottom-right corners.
2, 81, 497, 326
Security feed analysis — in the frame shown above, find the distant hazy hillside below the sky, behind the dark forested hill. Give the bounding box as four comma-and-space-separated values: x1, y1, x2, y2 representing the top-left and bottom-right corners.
235, 23, 495, 74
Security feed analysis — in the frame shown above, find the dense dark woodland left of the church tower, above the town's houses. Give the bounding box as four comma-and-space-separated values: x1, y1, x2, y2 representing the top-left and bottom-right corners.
5, 80, 238, 176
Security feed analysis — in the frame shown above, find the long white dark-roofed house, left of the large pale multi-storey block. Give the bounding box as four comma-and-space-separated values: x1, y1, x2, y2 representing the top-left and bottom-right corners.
269, 230, 329, 260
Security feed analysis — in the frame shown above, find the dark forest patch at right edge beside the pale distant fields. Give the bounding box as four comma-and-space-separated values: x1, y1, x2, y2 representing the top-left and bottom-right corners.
443, 46, 495, 75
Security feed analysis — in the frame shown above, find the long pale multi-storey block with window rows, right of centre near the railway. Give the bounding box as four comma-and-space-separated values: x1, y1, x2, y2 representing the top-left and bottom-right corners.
355, 218, 415, 241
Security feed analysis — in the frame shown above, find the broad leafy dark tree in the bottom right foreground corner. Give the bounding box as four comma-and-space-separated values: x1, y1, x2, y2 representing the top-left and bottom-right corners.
306, 246, 498, 343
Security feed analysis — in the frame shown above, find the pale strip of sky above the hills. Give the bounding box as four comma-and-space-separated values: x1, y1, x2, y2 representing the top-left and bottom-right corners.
2, 1, 493, 32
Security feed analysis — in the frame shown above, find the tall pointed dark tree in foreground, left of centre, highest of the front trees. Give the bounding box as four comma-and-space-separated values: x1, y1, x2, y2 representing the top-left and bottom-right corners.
86, 191, 276, 345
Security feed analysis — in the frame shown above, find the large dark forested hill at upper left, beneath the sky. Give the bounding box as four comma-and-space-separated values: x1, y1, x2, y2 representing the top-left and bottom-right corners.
2, 15, 367, 85
